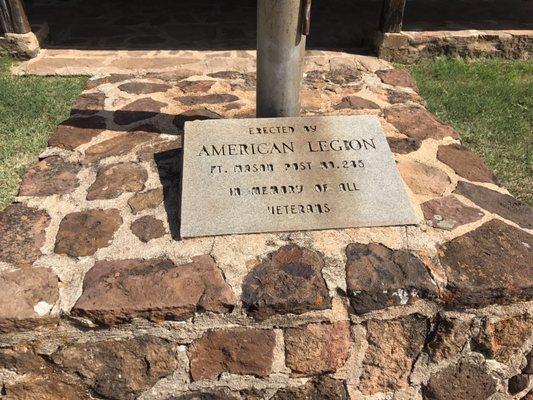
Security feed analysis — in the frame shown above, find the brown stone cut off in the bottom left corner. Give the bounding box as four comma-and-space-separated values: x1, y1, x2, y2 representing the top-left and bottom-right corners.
2, 375, 91, 400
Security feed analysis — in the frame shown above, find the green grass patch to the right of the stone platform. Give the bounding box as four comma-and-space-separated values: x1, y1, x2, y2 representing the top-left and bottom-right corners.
406, 59, 533, 206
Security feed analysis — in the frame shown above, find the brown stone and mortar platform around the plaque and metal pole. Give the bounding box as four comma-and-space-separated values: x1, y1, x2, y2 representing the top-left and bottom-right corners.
0, 53, 533, 400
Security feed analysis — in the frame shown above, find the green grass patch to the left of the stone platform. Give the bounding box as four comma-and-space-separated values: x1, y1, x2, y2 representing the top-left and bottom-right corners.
0, 56, 86, 210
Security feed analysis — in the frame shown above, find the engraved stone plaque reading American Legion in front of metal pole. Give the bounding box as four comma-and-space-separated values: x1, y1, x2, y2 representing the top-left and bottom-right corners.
181, 116, 417, 238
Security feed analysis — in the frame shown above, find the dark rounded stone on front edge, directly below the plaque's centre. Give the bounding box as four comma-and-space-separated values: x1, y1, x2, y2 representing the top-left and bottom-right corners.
242, 245, 331, 320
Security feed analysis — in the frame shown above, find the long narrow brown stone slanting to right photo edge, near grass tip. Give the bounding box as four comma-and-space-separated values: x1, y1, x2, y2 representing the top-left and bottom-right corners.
454, 181, 533, 229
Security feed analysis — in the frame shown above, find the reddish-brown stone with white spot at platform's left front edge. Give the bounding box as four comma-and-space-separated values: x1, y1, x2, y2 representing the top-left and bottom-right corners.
0, 268, 59, 332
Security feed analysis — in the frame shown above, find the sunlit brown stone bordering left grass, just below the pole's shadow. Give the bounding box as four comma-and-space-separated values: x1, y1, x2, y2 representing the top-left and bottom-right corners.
19, 156, 80, 196
